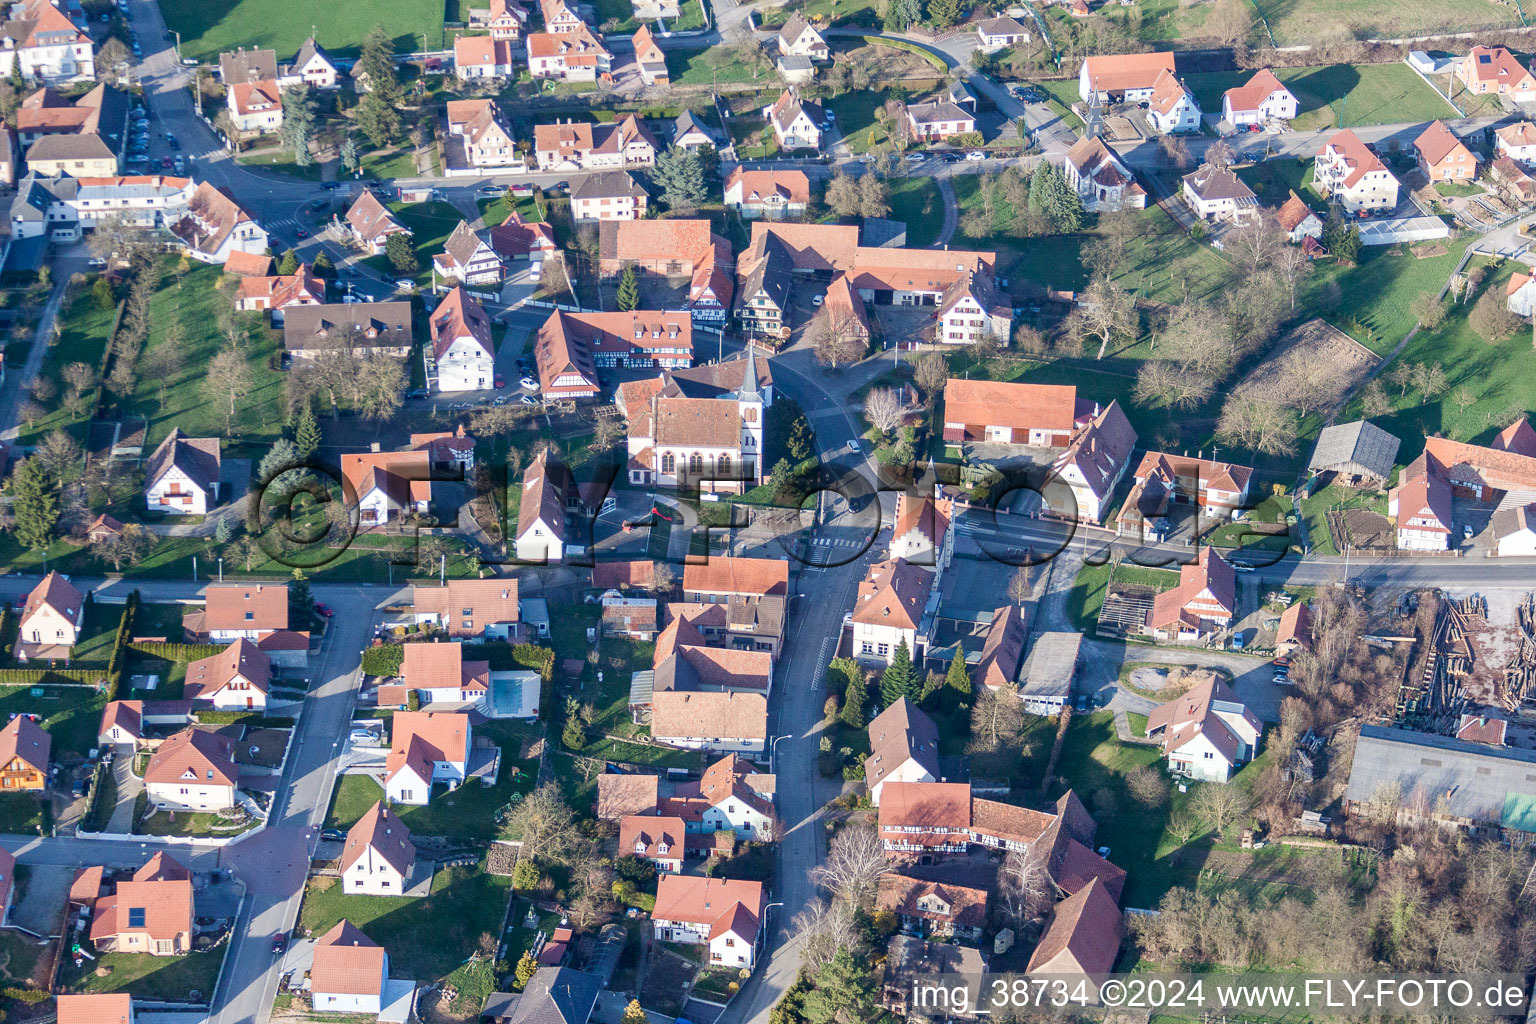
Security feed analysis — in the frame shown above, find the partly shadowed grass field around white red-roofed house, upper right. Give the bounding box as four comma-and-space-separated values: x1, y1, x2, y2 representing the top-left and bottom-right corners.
1184, 64, 1456, 130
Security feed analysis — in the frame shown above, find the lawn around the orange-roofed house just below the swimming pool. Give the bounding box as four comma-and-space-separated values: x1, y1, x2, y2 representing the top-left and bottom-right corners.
326, 722, 541, 840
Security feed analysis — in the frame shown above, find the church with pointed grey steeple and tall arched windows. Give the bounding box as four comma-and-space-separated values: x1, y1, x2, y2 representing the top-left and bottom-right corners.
614, 347, 773, 494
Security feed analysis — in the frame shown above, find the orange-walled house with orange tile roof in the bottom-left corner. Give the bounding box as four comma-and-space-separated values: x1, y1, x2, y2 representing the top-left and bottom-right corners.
91, 853, 192, 956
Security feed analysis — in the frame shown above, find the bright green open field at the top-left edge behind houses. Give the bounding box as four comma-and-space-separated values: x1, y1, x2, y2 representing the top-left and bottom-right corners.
160, 0, 444, 61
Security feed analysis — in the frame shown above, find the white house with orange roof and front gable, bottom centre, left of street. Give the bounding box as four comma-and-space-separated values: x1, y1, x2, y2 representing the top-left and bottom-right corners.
651, 875, 765, 970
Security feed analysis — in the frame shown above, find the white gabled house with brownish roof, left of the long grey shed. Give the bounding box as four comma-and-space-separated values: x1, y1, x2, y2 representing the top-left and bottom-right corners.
1147, 675, 1264, 783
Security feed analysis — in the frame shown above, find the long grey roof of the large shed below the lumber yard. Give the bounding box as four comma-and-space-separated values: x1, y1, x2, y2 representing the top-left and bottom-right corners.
1346, 725, 1536, 831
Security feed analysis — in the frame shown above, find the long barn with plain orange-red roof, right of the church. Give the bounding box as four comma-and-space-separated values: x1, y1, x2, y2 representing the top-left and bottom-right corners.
945, 378, 1100, 448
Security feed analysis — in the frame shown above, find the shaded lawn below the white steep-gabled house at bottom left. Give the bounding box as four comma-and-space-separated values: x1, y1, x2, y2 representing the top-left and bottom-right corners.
298, 861, 511, 1010
